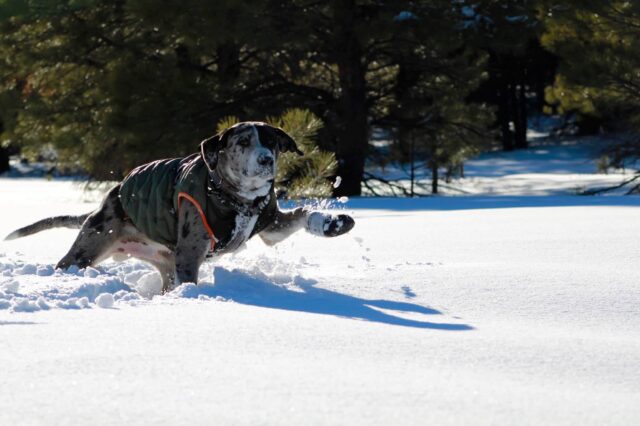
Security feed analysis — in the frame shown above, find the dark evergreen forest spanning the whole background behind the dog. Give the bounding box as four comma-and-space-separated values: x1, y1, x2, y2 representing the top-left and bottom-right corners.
0, 0, 640, 196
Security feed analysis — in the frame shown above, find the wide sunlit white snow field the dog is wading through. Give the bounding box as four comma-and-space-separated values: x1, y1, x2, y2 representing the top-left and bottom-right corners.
0, 142, 640, 425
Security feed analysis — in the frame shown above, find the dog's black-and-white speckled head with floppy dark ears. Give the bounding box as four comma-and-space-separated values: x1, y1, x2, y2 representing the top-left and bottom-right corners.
200, 122, 302, 199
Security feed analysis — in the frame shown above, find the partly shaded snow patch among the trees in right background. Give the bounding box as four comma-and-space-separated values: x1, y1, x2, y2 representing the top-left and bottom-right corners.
365, 134, 640, 196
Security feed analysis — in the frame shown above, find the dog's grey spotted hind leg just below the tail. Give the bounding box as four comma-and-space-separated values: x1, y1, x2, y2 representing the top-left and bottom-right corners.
56, 186, 124, 269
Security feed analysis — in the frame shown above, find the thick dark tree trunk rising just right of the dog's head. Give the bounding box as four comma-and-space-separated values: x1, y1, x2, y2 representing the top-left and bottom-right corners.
333, 0, 369, 196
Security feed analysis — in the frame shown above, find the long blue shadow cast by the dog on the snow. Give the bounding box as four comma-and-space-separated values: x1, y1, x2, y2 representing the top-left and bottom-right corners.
178, 267, 473, 331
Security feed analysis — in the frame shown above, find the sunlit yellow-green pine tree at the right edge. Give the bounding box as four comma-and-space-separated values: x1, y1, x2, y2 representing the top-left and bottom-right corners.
543, 0, 640, 191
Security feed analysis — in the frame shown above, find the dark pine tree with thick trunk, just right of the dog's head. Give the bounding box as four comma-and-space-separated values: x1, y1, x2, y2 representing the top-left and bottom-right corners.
250, 0, 496, 195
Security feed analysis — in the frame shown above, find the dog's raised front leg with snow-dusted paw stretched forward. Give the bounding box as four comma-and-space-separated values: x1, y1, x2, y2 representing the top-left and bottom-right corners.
259, 207, 355, 245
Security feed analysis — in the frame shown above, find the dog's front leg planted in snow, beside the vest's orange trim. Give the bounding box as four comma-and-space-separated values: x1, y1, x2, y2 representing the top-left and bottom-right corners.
175, 202, 211, 285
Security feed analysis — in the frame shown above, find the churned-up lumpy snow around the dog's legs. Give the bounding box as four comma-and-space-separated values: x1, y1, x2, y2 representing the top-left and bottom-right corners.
0, 257, 305, 312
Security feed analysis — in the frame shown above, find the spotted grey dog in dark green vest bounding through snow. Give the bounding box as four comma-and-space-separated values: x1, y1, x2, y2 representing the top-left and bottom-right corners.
6, 122, 354, 292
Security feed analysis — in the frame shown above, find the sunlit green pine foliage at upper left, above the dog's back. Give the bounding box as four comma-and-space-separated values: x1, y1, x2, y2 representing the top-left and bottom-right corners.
0, 0, 278, 179
